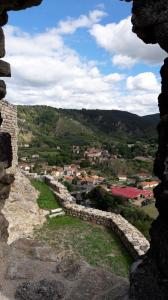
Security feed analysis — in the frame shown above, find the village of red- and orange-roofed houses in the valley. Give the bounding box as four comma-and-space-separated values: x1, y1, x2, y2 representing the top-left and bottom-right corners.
19, 145, 159, 207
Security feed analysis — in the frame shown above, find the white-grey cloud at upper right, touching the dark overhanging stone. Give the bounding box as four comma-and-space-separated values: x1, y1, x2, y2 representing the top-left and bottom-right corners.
90, 17, 166, 66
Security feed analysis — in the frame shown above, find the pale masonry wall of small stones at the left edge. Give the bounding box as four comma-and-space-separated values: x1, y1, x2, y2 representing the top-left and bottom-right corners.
0, 100, 18, 173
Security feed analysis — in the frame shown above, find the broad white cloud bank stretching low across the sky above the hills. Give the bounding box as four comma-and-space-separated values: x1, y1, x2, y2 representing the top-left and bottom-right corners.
5, 13, 159, 115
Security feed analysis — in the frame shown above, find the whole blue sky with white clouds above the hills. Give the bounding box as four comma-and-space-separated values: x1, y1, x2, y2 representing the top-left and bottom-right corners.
4, 0, 166, 115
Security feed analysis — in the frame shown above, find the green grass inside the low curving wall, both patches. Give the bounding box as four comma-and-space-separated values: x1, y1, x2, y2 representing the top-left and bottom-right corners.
33, 181, 132, 277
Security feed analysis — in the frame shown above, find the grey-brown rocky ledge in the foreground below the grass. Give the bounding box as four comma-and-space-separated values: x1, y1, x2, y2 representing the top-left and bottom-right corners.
0, 239, 129, 300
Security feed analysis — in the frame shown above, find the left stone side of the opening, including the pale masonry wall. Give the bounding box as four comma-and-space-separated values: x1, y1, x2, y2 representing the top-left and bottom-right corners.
0, 0, 42, 246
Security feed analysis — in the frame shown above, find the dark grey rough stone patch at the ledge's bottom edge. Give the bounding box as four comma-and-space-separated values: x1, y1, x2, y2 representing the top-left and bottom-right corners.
15, 279, 65, 300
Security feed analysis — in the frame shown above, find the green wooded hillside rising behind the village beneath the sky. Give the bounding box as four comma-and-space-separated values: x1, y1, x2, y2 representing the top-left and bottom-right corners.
18, 106, 158, 164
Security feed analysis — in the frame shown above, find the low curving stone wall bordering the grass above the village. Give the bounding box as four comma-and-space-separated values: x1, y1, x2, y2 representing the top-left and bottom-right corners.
44, 176, 149, 259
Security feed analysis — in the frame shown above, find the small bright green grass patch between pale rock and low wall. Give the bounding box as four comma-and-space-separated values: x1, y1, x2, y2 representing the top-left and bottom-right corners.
31, 180, 60, 210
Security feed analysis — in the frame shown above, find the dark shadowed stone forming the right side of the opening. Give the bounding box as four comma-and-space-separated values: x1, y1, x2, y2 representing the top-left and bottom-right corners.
122, 0, 168, 300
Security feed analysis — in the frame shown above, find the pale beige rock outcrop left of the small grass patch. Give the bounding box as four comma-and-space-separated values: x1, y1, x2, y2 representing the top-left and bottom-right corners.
2, 170, 46, 243
